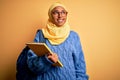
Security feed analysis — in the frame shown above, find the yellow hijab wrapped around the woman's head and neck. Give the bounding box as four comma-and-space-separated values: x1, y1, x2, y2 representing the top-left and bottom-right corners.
42, 3, 70, 45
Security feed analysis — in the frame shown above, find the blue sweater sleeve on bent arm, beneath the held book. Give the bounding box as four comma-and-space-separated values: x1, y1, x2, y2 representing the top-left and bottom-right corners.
27, 31, 53, 74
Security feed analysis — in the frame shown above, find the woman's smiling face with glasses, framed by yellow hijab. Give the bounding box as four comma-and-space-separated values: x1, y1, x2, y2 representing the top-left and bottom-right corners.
51, 6, 67, 27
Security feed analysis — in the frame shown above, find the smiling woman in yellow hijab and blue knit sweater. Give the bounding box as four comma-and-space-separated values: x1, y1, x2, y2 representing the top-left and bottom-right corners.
16, 3, 88, 80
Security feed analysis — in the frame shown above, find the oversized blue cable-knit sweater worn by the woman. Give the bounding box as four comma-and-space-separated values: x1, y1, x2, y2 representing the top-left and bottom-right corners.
25, 31, 88, 80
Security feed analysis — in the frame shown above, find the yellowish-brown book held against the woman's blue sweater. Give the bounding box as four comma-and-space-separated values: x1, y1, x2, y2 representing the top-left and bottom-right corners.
26, 42, 63, 67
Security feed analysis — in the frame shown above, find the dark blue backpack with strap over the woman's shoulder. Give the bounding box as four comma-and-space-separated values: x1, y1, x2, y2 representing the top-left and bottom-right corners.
16, 30, 45, 80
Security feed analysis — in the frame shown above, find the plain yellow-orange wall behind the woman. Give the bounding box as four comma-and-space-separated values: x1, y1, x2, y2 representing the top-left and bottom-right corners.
0, 0, 120, 80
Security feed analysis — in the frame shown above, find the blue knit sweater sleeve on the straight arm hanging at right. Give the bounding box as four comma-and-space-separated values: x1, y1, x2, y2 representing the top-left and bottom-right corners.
73, 33, 89, 80
